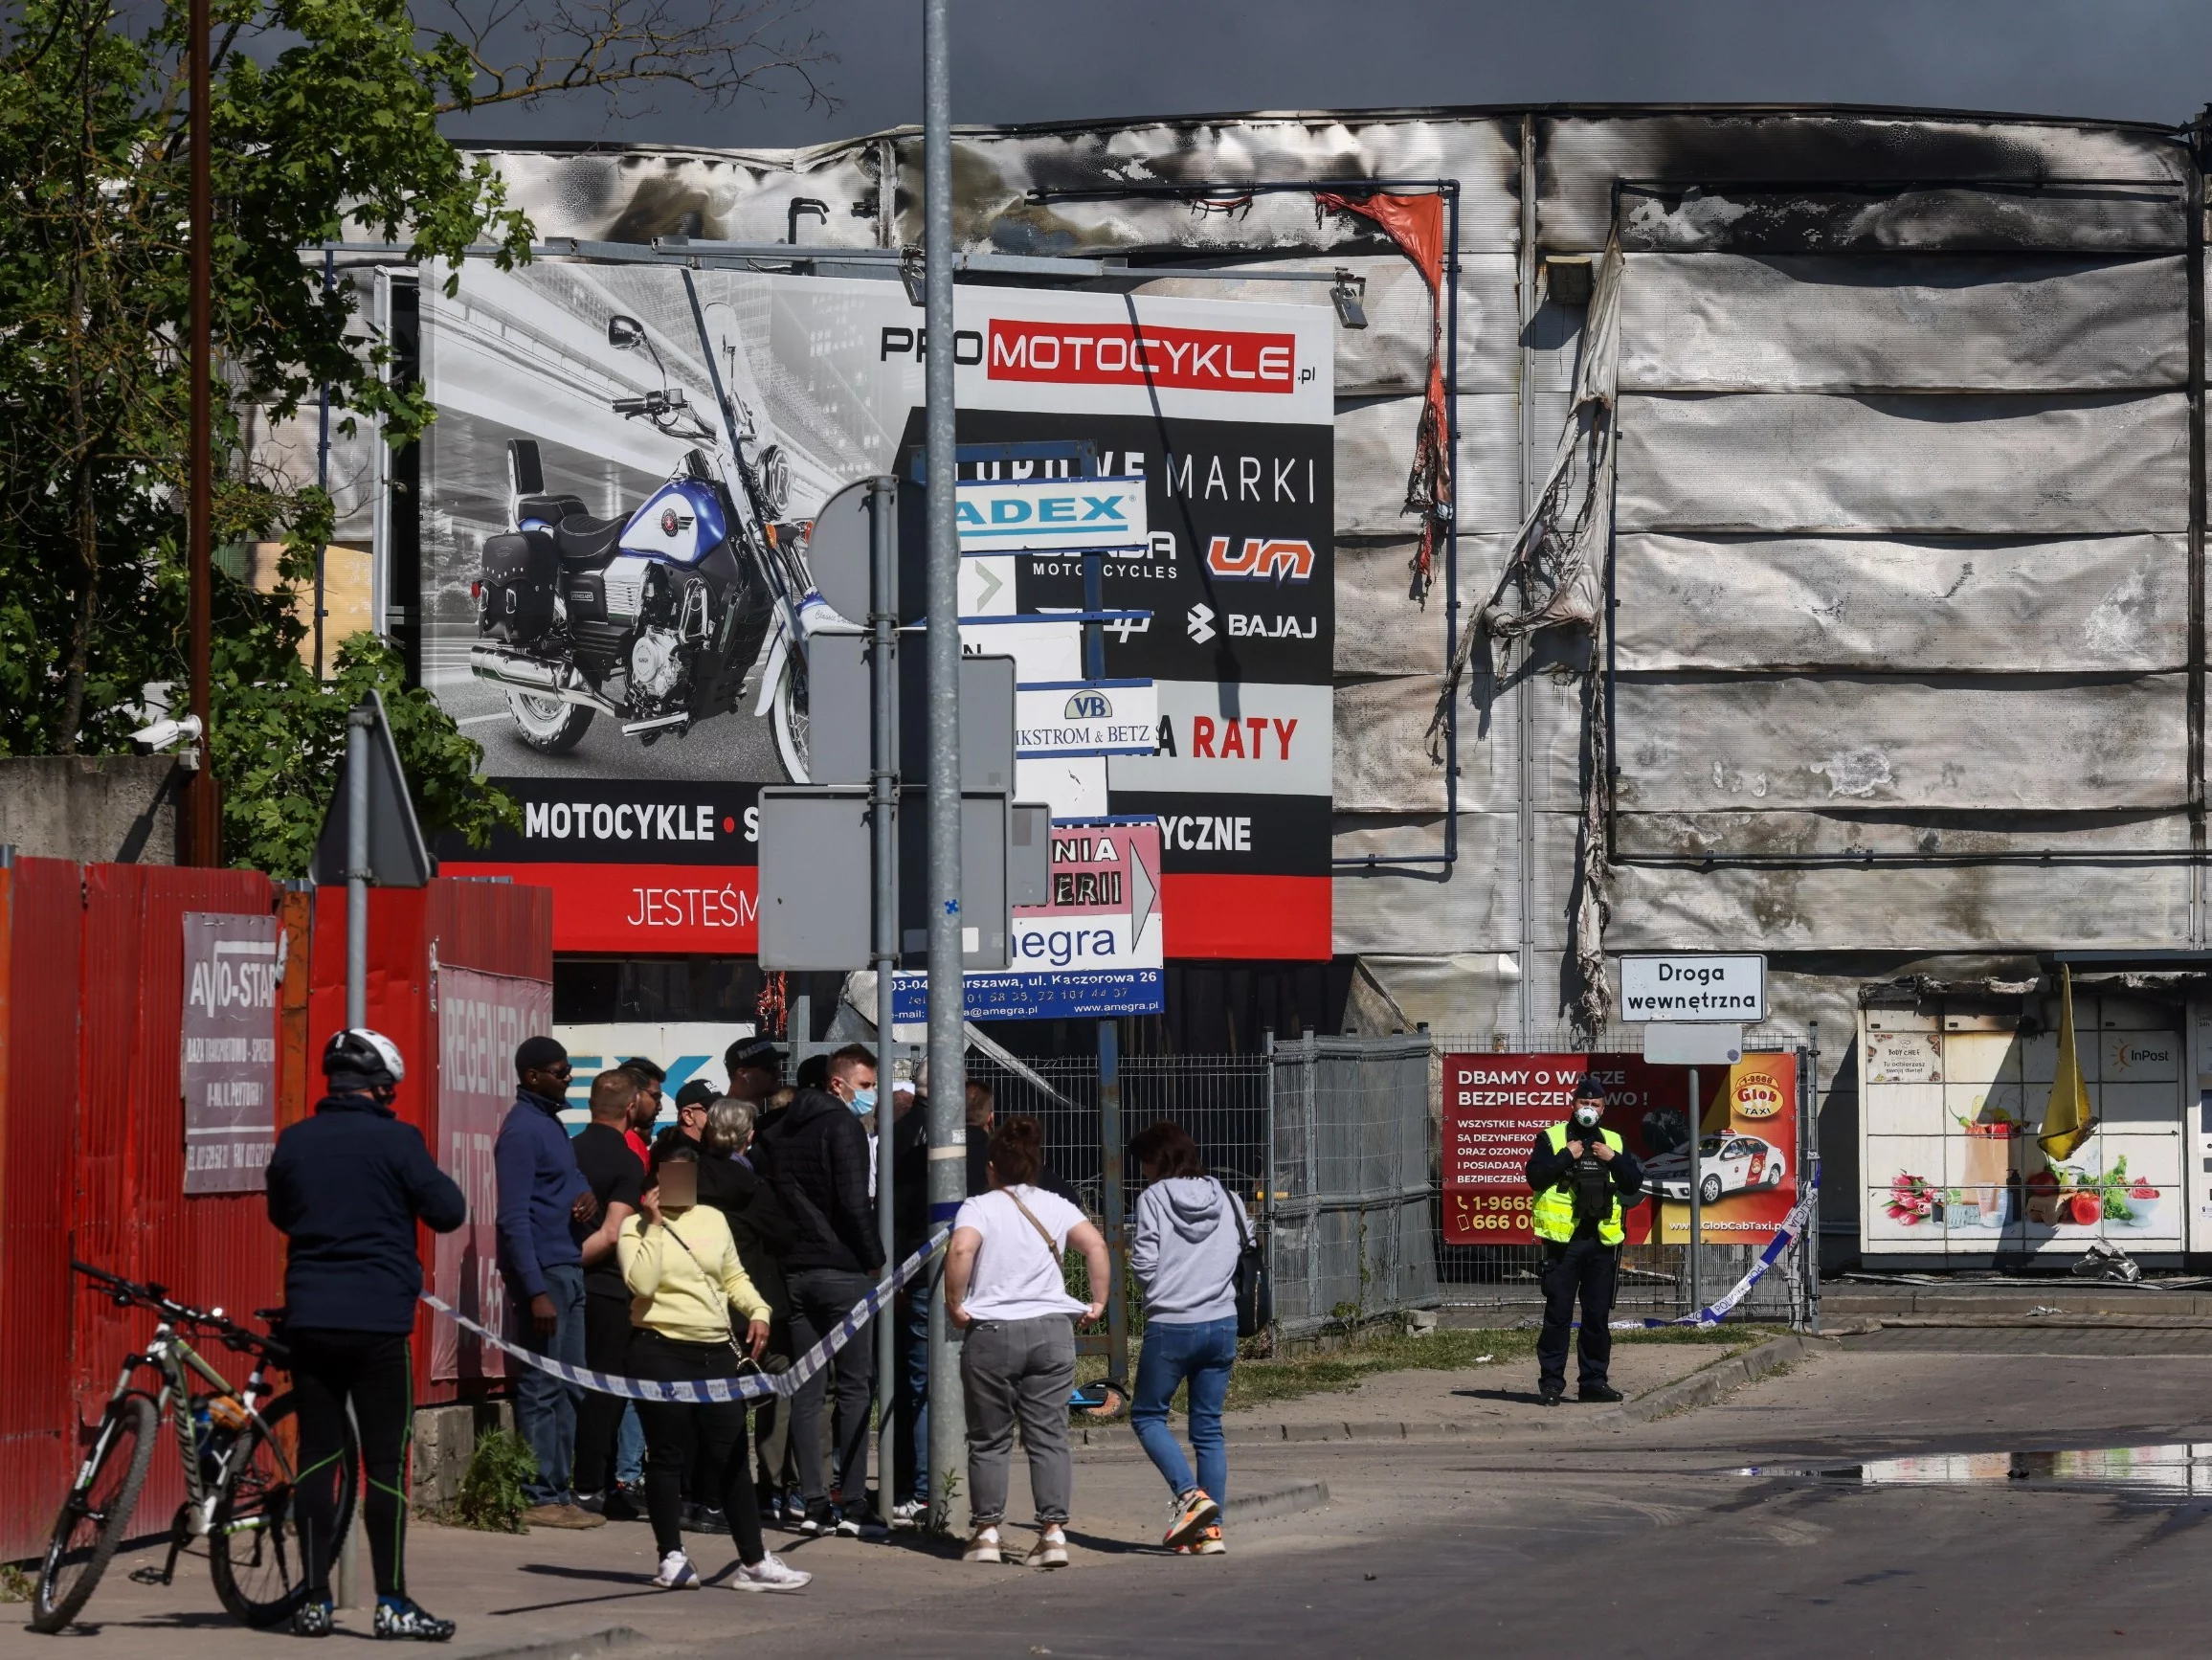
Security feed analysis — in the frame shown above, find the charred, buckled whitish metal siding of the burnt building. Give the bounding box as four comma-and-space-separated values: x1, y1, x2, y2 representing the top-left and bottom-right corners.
458, 108, 2205, 1107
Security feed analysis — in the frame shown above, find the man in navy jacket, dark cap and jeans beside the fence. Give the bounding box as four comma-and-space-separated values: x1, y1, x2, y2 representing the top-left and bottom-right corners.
491, 1038, 606, 1527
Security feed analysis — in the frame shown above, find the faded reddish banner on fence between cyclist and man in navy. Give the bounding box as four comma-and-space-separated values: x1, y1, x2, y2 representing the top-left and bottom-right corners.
429, 967, 553, 1381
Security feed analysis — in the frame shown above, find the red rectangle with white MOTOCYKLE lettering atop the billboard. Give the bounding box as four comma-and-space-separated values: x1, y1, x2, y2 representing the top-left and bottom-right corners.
984, 317, 1314, 392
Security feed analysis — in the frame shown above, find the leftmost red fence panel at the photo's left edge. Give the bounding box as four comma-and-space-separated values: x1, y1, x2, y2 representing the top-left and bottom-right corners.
0, 859, 82, 1560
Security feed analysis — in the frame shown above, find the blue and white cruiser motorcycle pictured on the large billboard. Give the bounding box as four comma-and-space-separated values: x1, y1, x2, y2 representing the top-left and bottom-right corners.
469, 272, 831, 781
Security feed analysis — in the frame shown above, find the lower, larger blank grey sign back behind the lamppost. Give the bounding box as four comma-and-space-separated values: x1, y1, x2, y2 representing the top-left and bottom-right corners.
759, 786, 1013, 970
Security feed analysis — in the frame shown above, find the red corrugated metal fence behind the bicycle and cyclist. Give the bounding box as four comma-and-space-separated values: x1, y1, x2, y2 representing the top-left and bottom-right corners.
0, 859, 553, 1560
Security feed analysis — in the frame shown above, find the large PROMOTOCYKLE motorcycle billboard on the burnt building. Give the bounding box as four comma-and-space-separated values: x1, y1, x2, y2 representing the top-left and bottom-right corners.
420, 261, 1334, 958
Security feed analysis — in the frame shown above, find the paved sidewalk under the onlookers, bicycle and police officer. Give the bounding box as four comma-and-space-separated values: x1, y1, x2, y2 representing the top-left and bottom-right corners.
0, 1346, 1752, 1660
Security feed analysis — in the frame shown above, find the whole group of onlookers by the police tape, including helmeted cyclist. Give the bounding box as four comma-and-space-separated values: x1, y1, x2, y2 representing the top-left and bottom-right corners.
270, 1029, 1250, 1640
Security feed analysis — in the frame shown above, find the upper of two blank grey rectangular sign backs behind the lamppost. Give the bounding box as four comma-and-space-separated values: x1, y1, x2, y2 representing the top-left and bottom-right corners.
808, 629, 1017, 796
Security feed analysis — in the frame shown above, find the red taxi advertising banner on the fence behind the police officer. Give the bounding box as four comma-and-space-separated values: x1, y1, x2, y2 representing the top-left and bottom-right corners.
1442, 1054, 1799, 1244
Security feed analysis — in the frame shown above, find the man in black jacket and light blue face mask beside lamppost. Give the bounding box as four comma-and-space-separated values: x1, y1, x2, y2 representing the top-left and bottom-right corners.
759, 1043, 884, 1538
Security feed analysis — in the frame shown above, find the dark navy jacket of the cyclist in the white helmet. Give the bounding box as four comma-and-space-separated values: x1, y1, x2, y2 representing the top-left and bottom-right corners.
268, 1095, 469, 1335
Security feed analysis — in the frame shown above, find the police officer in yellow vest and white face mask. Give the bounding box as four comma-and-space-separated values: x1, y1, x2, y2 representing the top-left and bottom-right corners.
1529, 1076, 1643, 1405
